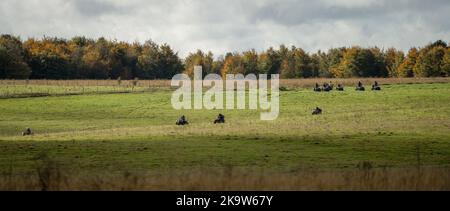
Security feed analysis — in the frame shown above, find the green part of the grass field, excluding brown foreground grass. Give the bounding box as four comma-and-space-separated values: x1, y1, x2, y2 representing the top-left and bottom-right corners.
0, 83, 450, 174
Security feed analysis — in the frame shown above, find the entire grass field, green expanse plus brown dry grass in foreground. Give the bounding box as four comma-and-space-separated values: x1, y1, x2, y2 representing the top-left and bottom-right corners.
0, 79, 450, 190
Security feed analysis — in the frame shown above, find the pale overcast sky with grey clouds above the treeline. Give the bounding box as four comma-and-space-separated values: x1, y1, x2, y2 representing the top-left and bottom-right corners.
0, 0, 450, 56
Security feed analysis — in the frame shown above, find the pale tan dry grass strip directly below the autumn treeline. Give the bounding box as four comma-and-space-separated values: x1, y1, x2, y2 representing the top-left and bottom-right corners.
0, 78, 450, 98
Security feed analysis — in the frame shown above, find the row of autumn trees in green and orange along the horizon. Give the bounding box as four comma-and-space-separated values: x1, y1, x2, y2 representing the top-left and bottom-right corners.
0, 35, 450, 79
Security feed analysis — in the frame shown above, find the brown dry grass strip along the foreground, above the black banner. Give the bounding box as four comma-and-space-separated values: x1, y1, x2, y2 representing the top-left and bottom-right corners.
0, 164, 450, 191
